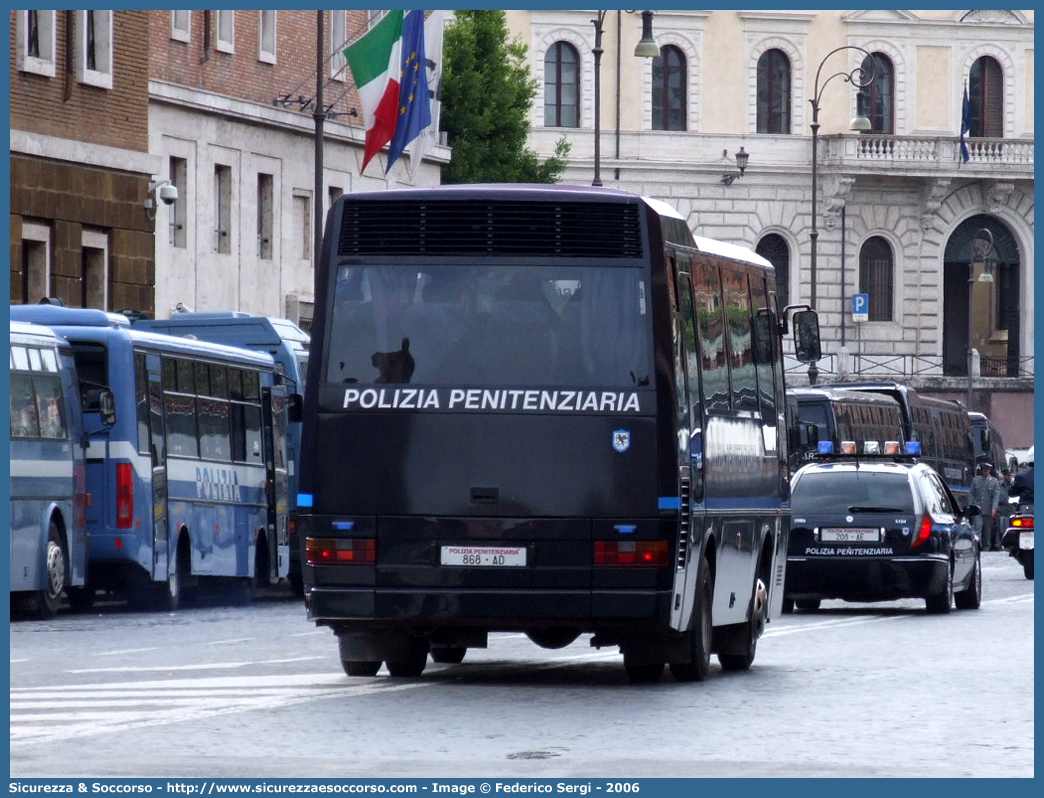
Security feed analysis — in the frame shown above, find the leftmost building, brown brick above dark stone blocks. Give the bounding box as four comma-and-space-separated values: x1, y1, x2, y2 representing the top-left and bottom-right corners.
9, 10, 159, 312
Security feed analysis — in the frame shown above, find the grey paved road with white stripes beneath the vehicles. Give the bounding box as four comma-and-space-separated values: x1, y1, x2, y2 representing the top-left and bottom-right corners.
10, 554, 1034, 779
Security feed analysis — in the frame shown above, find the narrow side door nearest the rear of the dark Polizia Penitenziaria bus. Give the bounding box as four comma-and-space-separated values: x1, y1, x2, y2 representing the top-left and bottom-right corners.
668, 259, 703, 632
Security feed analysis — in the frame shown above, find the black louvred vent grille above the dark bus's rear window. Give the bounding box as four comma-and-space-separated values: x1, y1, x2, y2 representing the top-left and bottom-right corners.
337, 200, 642, 258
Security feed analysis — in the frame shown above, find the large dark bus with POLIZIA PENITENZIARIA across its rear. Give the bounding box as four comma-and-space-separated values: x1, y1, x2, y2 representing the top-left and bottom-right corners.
298, 185, 818, 681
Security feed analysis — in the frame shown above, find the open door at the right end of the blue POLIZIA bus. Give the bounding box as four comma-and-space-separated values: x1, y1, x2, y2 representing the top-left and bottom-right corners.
258, 385, 290, 580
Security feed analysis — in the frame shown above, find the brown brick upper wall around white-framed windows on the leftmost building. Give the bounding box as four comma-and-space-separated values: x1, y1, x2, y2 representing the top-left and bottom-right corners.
9, 10, 149, 152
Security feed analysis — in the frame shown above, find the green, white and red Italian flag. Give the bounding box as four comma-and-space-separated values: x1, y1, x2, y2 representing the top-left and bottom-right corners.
345, 10, 403, 173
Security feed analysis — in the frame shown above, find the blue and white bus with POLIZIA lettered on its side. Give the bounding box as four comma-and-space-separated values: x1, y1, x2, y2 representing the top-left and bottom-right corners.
11, 305, 289, 609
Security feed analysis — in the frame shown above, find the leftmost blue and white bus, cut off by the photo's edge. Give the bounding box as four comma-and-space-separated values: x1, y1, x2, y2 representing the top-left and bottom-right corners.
8, 322, 87, 619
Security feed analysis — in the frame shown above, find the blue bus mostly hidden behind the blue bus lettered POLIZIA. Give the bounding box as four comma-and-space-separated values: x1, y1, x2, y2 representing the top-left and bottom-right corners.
133, 310, 310, 594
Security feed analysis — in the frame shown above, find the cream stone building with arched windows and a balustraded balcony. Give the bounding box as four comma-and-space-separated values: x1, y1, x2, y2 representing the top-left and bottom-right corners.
508, 9, 1035, 447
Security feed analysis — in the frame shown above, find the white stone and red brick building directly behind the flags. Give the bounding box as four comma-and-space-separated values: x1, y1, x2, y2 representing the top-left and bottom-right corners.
148, 10, 449, 327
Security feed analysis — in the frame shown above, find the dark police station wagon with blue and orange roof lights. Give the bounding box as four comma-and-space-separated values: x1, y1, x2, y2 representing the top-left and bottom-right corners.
784, 441, 982, 613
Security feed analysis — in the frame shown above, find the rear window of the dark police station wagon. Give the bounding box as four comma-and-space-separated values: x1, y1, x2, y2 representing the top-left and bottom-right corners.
790, 469, 914, 515
